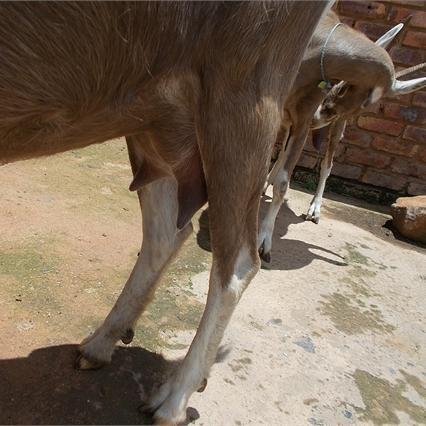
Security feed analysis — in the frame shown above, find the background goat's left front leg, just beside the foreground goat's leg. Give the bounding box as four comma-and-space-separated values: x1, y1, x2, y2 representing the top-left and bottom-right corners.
258, 123, 308, 263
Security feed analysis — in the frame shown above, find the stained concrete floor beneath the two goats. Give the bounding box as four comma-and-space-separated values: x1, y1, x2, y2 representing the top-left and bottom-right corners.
0, 141, 426, 425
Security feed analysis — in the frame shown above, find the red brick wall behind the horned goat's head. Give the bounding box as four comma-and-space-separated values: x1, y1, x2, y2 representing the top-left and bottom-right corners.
299, 0, 426, 195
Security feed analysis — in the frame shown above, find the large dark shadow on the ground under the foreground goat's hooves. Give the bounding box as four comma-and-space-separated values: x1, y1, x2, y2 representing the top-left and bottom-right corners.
0, 345, 199, 424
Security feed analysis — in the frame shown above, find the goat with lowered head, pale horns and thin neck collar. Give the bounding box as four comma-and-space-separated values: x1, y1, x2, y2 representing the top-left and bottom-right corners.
258, 11, 426, 262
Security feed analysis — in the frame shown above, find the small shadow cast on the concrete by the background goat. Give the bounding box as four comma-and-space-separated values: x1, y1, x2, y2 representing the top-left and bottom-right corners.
197, 196, 347, 271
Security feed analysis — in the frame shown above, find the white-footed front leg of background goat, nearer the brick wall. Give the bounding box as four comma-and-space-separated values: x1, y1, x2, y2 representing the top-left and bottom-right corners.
306, 119, 346, 223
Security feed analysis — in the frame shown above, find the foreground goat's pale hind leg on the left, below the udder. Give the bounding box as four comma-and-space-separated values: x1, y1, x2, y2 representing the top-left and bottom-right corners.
76, 146, 192, 369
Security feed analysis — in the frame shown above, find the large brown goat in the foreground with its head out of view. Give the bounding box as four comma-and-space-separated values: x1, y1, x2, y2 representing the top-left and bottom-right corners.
0, 1, 330, 424
